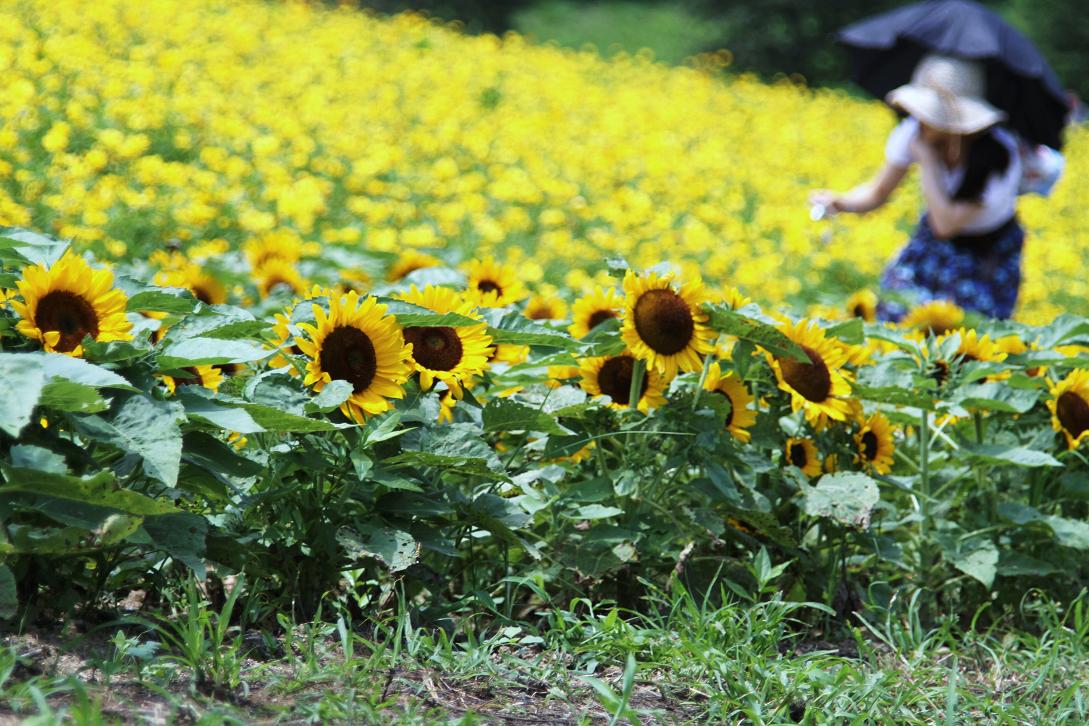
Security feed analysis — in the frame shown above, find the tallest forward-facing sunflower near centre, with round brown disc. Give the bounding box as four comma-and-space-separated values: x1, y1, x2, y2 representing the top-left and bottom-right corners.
621, 270, 718, 380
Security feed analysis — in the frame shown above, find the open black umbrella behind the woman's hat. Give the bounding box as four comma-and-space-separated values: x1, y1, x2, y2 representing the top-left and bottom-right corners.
837, 0, 1077, 149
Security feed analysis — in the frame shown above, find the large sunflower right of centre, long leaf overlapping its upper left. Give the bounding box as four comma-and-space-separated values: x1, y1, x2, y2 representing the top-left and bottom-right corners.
769, 319, 852, 424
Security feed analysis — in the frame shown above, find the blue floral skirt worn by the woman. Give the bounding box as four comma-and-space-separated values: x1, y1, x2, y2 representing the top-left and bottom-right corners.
878, 216, 1025, 321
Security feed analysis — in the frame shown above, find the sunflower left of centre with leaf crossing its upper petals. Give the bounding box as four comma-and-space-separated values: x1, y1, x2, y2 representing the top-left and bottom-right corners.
397, 285, 493, 391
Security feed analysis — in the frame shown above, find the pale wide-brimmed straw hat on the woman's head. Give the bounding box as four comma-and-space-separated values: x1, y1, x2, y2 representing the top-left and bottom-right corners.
885, 56, 1006, 134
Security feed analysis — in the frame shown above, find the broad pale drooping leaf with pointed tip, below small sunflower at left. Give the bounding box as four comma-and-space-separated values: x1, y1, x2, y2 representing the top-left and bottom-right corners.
76, 395, 185, 487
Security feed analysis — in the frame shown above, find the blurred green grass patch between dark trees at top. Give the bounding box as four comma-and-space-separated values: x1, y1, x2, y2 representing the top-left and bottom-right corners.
513, 0, 722, 63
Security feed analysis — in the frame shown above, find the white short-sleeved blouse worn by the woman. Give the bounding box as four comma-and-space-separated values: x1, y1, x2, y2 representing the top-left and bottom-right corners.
885, 116, 1021, 234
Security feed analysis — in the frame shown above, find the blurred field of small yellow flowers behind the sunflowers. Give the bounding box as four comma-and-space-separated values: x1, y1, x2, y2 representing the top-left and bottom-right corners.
0, 0, 1089, 323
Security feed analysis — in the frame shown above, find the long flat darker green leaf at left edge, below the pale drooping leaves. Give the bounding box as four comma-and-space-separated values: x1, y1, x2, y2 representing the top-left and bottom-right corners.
0, 465, 176, 516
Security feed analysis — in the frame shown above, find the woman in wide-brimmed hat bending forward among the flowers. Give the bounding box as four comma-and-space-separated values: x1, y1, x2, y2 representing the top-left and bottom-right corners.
810, 56, 1025, 320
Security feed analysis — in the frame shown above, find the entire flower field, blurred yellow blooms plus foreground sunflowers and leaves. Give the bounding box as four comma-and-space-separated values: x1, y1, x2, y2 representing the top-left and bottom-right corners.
0, 0, 1089, 709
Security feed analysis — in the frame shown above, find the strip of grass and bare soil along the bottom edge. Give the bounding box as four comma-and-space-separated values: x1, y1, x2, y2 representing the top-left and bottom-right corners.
0, 581, 1089, 724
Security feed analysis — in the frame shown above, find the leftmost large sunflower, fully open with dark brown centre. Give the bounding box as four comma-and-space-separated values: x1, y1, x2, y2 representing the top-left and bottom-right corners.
11, 249, 133, 356
